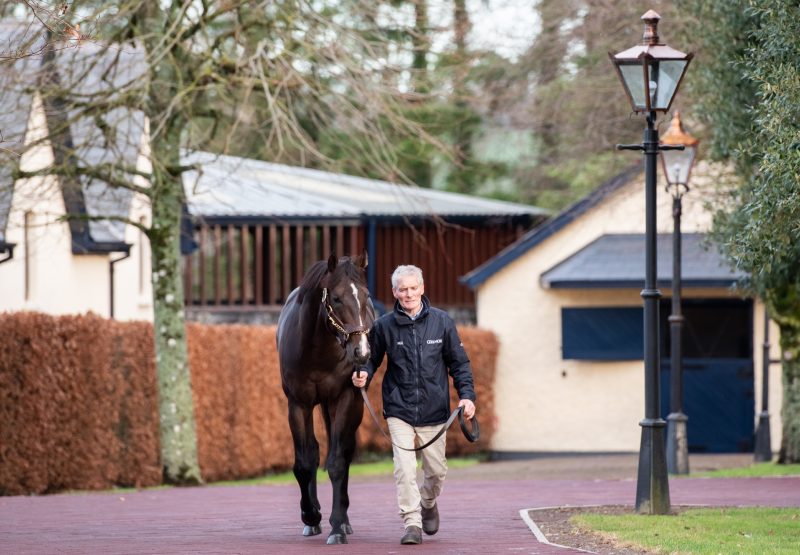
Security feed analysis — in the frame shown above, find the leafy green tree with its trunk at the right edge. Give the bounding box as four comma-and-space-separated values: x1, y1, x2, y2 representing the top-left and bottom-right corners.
685, 0, 800, 463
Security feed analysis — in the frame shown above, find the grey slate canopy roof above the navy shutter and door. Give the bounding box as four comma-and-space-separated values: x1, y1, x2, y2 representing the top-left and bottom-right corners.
540, 233, 745, 289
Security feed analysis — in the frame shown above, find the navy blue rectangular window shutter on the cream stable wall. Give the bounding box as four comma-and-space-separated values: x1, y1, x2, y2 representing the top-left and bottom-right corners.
561, 306, 644, 360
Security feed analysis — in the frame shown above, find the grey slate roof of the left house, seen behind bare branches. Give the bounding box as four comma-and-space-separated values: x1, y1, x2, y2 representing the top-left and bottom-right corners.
0, 20, 146, 253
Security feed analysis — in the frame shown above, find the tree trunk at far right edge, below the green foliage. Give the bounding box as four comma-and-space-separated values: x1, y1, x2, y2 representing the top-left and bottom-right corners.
778, 324, 800, 464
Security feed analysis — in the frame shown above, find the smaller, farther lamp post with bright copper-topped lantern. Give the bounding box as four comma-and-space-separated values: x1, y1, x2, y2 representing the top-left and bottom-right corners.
661, 112, 699, 474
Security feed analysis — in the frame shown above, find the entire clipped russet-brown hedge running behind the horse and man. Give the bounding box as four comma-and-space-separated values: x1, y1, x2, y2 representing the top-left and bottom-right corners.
0, 312, 497, 495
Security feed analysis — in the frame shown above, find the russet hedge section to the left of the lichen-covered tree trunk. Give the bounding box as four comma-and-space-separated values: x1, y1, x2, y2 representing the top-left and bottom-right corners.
0, 313, 161, 494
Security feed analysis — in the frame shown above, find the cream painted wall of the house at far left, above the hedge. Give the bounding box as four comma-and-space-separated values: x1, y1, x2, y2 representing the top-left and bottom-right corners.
0, 97, 152, 320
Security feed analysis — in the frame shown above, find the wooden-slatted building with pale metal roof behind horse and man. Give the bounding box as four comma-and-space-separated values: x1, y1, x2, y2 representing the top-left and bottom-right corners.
183, 152, 549, 323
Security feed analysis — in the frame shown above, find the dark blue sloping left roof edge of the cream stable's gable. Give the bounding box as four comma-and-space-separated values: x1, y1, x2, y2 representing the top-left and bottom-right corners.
459, 162, 643, 289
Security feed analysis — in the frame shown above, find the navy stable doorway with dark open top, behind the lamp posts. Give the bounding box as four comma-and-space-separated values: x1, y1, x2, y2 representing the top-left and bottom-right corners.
660, 299, 755, 453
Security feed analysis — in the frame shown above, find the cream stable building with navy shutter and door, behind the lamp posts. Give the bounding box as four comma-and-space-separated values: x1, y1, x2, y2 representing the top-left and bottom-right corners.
462, 163, 782, 458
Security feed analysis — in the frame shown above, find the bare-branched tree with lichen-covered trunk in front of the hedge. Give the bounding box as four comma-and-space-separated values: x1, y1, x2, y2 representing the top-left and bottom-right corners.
4, 0, 444, 483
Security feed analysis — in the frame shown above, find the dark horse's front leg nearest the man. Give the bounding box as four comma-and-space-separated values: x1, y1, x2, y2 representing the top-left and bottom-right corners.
326, 388, 364, 544
